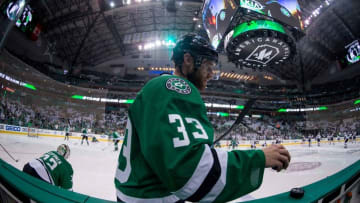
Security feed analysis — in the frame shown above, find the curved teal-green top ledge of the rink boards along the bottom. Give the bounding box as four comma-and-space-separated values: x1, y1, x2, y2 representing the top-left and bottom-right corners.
0, 159, 360, 203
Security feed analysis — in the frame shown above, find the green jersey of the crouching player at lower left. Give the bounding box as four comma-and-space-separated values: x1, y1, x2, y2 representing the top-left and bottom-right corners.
35, 151, 74, 190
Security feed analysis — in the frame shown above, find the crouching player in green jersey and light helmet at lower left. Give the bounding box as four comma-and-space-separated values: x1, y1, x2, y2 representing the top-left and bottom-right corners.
23, 144, 74, 190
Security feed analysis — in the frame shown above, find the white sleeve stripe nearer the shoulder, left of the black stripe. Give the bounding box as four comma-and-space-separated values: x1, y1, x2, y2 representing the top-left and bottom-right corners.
174, 145, 214, 199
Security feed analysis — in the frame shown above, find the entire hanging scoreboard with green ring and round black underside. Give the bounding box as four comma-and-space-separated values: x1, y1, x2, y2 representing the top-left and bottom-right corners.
202, 0, 304, 69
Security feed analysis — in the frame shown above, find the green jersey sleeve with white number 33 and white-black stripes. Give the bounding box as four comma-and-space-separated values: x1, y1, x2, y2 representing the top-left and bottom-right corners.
130, 76, 265, 202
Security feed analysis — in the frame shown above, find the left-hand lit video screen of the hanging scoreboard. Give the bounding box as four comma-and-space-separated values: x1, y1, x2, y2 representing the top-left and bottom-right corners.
202, 0, 238, 49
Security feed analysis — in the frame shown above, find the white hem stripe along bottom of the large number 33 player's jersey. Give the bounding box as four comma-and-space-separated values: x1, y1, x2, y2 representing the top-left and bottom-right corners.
116, 189, 179, 203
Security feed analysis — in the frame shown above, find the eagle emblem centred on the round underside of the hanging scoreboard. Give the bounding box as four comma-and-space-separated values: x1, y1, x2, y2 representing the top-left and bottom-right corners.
246, 44, 280, 65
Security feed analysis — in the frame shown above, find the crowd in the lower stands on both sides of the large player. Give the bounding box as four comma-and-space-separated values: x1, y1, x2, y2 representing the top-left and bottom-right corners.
0, 95, 360, 140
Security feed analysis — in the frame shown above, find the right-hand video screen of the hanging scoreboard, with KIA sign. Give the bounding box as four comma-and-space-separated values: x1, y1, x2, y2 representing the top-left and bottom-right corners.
239, 0, 304, 30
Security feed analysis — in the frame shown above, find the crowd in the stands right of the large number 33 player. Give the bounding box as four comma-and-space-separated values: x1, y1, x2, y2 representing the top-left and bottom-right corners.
209, 115, 360, 140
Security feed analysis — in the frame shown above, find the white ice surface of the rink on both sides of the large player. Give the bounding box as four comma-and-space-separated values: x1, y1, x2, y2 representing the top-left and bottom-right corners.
0, 134, 360, 202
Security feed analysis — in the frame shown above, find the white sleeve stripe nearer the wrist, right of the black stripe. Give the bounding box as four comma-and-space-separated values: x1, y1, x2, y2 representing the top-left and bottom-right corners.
200, 149, 228, 202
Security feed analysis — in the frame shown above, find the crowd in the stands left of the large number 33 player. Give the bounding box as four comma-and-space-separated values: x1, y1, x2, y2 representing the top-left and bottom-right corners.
0, 96, 127, 134
